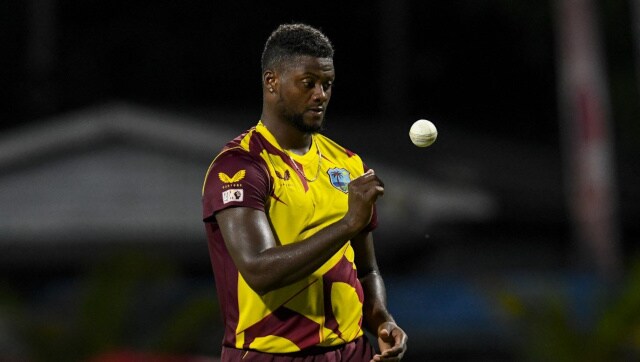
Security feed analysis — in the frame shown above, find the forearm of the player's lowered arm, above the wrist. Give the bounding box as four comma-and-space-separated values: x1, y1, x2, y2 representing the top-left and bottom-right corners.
360, 269, 395, 334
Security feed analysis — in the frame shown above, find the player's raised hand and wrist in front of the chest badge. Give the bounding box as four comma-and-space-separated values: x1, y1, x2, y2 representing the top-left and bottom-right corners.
345, 170, 384, 231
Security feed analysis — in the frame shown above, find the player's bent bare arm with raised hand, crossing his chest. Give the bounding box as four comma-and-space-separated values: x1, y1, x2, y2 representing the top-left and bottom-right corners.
215, 170, 384, 295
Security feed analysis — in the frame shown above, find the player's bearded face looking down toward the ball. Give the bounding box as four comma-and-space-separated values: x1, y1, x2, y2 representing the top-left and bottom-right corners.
270, 56, 335, 133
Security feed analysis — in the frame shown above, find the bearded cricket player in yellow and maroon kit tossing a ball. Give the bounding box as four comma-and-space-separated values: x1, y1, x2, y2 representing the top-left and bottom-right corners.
203, 24, 407, 361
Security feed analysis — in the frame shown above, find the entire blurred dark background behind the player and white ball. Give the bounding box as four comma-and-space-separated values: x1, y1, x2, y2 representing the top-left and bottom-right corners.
0, 0, 640, 361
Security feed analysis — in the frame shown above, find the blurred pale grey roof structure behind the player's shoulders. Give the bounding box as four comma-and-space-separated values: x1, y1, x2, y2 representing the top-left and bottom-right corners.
0, 103, 496, 262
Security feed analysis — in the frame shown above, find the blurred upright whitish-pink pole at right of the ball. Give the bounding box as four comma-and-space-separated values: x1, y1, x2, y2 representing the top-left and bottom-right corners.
554, 0, 621, 278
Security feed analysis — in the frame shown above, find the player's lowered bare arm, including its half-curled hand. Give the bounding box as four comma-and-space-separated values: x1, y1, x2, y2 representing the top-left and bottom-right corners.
351, 232, 407, 361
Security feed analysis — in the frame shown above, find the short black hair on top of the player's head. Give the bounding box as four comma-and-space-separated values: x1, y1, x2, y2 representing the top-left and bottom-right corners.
262, 24, 333, 72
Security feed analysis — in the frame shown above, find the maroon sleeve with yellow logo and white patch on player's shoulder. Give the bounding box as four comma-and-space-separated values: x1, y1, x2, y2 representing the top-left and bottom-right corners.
202, 149, 271, 221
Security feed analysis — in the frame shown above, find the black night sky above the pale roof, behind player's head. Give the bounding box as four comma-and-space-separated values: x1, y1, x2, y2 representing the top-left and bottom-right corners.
0, 1, 576, 143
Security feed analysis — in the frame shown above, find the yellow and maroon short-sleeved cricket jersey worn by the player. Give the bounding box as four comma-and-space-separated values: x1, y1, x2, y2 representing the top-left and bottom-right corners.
202, 122, 376, 353
